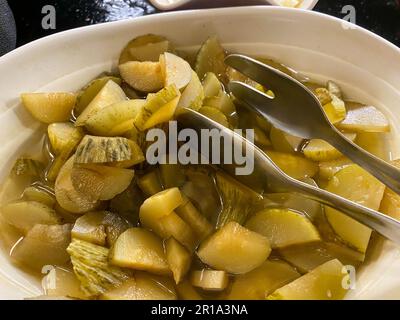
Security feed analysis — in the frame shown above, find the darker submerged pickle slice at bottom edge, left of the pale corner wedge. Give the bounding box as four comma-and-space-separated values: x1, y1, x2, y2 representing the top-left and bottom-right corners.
227, 260, 300, 300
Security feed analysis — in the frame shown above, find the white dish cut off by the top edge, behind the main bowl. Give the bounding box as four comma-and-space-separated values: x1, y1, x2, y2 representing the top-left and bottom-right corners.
150, 0, 318, 11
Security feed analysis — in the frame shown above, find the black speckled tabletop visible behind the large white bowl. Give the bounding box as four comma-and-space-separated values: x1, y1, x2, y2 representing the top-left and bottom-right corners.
8, 0, 400, 46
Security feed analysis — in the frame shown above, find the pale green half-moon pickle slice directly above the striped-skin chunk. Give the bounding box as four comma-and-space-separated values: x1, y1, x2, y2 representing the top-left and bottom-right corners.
85, 99, 145, 137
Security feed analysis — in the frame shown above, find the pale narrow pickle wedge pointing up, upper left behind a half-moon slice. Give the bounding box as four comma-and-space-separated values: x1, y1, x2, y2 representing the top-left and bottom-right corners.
75, 80, 127, 126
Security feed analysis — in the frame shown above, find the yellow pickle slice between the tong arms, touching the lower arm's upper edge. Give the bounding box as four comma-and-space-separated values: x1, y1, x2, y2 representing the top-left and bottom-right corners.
265, 150, 318, 179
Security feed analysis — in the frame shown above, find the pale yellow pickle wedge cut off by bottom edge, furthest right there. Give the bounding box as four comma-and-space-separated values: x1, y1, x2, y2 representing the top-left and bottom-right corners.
267, 259, 347, 300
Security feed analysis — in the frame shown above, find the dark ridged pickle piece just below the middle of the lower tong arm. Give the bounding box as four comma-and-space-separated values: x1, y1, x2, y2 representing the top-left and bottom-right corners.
216, 172, 262, 228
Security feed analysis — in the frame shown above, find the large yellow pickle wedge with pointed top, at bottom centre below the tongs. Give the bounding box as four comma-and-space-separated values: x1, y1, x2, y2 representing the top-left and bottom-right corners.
197, 221, 271, 274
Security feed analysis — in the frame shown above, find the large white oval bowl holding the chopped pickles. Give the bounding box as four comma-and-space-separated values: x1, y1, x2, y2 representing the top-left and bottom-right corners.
0, 6, 400, 299
